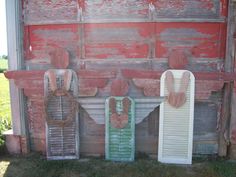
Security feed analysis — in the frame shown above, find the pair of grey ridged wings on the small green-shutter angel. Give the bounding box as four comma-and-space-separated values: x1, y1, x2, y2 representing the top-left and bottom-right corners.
78, 97, 164, 124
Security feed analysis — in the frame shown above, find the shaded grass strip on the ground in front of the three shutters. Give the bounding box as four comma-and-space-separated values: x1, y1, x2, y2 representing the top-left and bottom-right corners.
0, 154, 236, 177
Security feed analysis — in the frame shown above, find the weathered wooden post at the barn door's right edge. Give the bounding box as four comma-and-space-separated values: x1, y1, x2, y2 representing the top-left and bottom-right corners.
218, 0, 236, 158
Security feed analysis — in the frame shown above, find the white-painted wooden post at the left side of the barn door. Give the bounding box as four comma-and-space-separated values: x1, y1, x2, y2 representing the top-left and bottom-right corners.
6, 0, 26, 135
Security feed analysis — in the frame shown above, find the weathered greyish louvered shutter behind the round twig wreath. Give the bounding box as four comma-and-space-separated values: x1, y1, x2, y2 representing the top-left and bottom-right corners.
44, 70, 79, 160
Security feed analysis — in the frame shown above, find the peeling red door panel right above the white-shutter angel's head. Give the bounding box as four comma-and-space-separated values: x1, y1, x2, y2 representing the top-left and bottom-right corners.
156, 23, 226, 58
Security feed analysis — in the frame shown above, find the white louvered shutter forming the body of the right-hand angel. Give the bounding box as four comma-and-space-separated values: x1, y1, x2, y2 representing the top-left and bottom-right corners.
158, 70, 195, 164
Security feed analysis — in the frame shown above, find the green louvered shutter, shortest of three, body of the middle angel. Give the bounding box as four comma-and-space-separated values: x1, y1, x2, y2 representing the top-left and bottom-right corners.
105, 97, 135, 161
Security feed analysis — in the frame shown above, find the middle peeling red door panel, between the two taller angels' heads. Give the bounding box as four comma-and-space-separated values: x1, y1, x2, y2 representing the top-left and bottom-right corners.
85, 23, 151, 59
